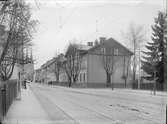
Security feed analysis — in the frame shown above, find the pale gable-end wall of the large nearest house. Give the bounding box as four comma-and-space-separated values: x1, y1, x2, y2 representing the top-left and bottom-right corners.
87, 41, 132, 87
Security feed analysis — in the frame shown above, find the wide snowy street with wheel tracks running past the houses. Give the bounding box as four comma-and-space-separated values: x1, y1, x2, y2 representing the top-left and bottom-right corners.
30, 84, 167, 124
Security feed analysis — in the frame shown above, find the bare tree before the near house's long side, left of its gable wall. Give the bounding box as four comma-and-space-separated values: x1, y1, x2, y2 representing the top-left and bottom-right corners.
64, 43, 81, 87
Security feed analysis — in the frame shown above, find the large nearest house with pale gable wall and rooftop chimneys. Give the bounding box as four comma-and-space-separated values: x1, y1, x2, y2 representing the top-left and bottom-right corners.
60, 37, 133, 87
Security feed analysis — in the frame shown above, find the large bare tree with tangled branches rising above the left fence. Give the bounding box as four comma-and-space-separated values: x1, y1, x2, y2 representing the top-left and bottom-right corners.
0, 0, 37, 81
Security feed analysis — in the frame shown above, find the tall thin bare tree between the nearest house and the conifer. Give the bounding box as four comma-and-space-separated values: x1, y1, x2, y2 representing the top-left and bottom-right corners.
126, 23, 146, 82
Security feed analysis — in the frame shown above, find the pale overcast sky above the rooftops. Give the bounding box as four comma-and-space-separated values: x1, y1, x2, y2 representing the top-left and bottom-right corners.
28, 0, 166, 69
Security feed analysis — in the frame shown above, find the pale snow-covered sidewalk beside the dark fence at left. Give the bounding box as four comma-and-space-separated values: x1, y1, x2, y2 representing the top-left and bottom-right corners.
3, 86, 50, 124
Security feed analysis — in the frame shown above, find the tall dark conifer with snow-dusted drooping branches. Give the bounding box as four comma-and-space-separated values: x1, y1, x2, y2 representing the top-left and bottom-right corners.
142, 12, 166, 89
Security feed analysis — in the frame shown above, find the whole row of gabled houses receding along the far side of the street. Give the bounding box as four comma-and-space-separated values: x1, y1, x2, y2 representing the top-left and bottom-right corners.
35, 37, 133, 87
